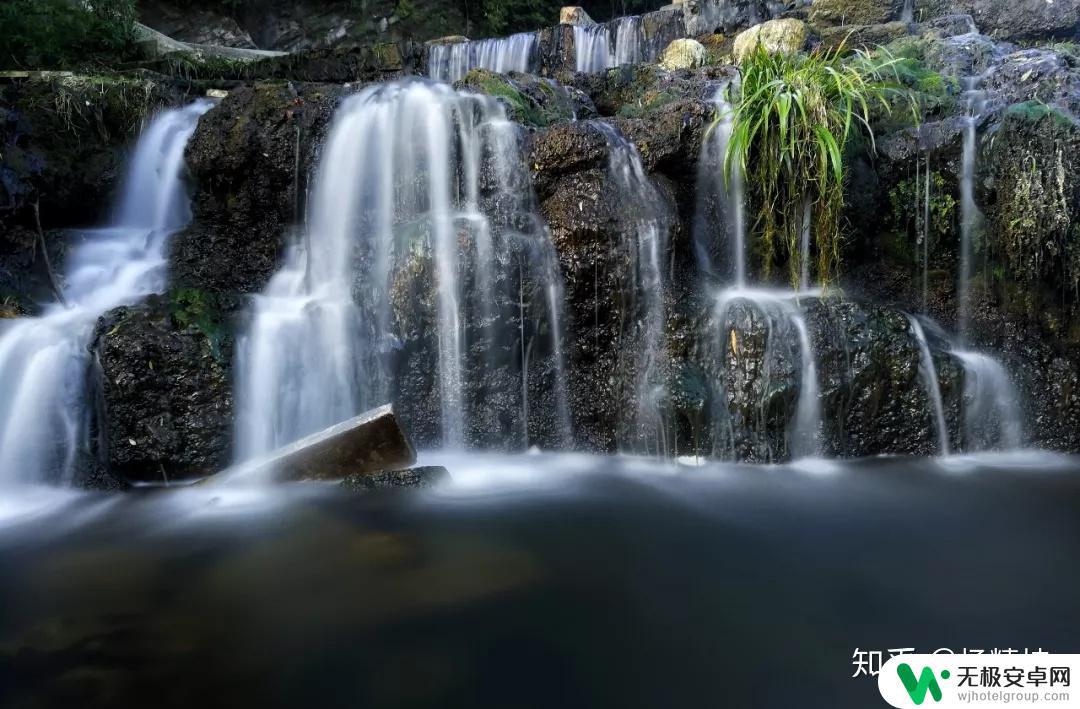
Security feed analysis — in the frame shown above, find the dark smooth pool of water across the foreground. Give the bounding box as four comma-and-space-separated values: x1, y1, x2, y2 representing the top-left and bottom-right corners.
0, 453, 1080, 709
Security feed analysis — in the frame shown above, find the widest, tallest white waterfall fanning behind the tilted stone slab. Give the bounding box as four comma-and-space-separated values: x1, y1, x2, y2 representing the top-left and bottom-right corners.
235, 80, 569, 460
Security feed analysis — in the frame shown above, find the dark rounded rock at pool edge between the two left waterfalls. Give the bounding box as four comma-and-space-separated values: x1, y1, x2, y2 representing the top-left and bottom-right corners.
94, 296, 232, 482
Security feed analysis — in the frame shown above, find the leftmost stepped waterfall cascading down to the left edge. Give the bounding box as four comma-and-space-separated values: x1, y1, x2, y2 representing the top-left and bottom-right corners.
0, 101, 213, 483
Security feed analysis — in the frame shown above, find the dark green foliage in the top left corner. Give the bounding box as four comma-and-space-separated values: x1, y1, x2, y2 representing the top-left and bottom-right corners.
0, 0, 136, 69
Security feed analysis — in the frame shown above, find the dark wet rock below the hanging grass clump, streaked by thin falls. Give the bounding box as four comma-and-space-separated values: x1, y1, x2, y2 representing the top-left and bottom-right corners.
686, 298, 963, 463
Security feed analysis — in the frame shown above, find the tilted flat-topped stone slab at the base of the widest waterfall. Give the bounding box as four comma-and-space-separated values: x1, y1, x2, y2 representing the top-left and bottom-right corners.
225, 404, 416, 481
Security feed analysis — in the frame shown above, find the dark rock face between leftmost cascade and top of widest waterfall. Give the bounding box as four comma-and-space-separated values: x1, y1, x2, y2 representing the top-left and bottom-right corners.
170, 83, 342, 293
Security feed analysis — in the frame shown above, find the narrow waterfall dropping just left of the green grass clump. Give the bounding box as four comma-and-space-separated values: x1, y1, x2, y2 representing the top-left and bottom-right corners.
693, 80, 746, 287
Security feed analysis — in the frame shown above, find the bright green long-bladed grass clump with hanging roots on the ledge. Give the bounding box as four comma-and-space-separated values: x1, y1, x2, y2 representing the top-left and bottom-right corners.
725, 46, 897, 285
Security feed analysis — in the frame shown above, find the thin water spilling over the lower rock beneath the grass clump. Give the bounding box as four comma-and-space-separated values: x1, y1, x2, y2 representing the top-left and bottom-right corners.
710, 287, 822, 458
